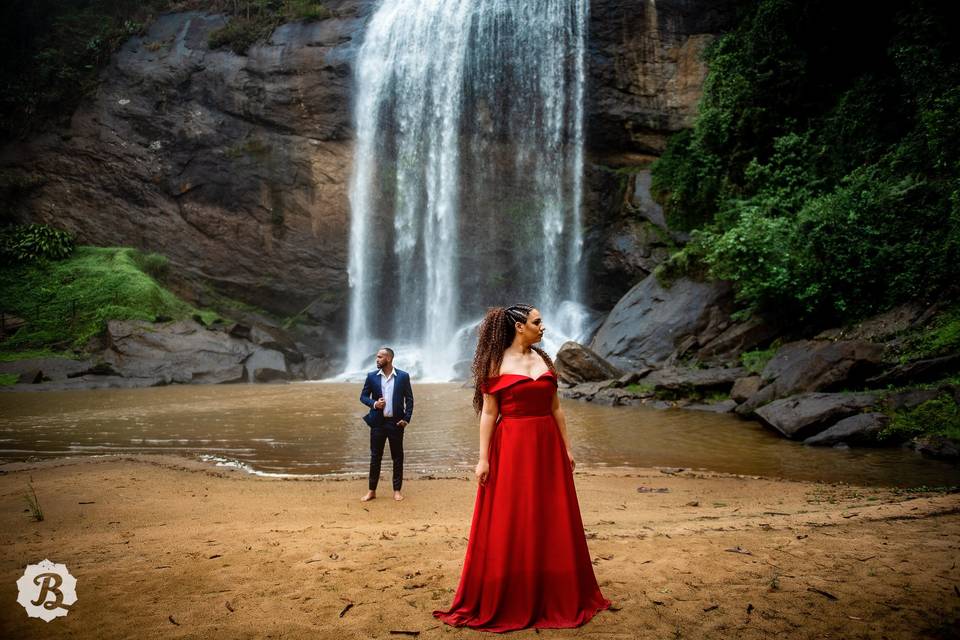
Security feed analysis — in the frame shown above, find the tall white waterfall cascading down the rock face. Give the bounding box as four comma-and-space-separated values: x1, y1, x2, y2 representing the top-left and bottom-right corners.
344, 0, 588, 380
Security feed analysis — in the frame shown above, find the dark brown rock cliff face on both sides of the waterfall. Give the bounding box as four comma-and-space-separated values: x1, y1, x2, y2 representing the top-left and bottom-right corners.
0, 0, 732, 350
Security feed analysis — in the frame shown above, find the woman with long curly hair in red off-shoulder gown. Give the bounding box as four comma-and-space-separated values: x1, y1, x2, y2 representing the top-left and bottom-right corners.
433, 304, 610, 632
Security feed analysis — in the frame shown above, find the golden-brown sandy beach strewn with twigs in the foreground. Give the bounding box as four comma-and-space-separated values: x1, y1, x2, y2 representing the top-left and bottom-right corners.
0, 455, 960, 639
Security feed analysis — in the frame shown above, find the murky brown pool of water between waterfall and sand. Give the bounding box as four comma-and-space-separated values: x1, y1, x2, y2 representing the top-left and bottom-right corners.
0, 382, 960, 486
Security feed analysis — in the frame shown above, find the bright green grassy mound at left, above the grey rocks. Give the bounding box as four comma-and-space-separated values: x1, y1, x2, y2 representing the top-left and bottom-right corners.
0, 246, 224, 357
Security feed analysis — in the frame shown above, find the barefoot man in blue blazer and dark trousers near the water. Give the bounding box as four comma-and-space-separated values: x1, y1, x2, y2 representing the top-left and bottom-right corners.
360, 347, 413, 502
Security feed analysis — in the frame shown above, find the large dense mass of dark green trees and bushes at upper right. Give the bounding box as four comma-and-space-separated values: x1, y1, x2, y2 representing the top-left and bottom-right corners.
652, 0, 960, 325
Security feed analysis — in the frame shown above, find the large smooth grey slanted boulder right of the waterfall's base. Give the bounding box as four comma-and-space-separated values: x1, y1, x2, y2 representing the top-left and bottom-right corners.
590, 274, 732, 371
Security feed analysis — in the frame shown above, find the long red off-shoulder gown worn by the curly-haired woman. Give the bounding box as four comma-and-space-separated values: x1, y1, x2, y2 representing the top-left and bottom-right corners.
433, 371, 610, 632
